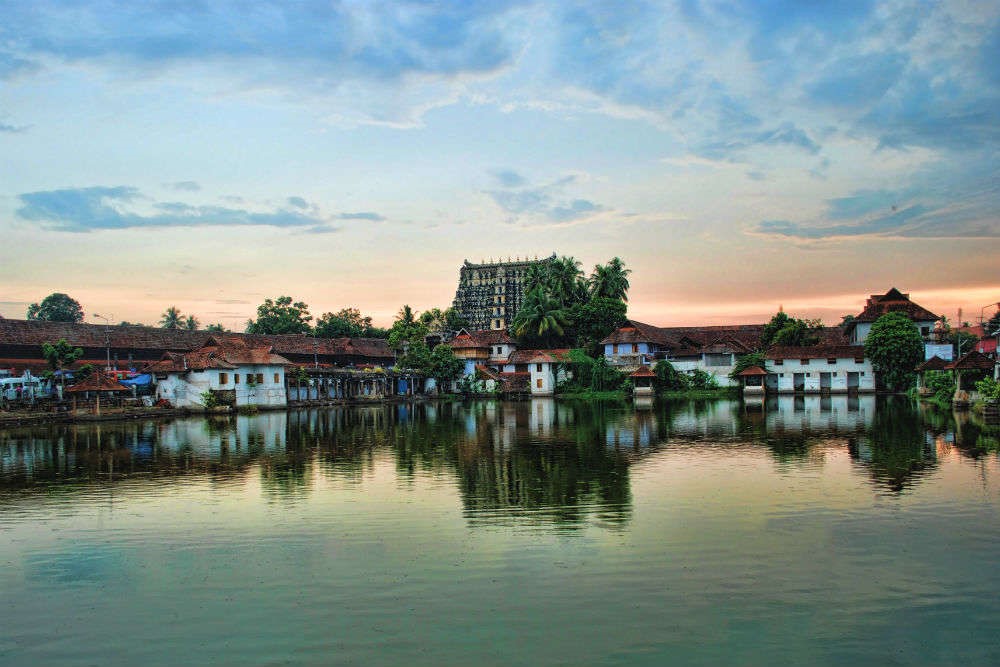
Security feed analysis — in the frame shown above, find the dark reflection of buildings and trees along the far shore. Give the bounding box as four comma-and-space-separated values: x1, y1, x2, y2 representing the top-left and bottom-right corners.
0, 395, 998, 516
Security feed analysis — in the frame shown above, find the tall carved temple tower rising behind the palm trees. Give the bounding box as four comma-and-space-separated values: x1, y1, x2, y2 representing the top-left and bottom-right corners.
452, 253, 556, 330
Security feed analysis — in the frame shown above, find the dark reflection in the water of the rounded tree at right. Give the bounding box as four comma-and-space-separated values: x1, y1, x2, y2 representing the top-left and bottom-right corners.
849, 396, 936, 492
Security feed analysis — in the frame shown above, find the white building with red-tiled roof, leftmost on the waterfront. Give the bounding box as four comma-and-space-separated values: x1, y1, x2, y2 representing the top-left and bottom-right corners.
146, 336, 290, 408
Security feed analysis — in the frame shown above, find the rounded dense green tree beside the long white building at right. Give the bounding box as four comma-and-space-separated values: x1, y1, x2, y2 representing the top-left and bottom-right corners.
865, 313, 924, 391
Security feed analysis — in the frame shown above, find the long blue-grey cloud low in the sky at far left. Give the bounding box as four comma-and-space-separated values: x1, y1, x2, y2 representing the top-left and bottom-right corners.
17, 186, 325, 232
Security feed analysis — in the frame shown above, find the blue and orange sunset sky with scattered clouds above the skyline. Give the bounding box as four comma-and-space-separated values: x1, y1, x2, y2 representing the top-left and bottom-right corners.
0, 0, 1000, 330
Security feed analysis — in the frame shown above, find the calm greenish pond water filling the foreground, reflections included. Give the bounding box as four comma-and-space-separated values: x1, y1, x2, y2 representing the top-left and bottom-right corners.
0, 397, 1000, 666
